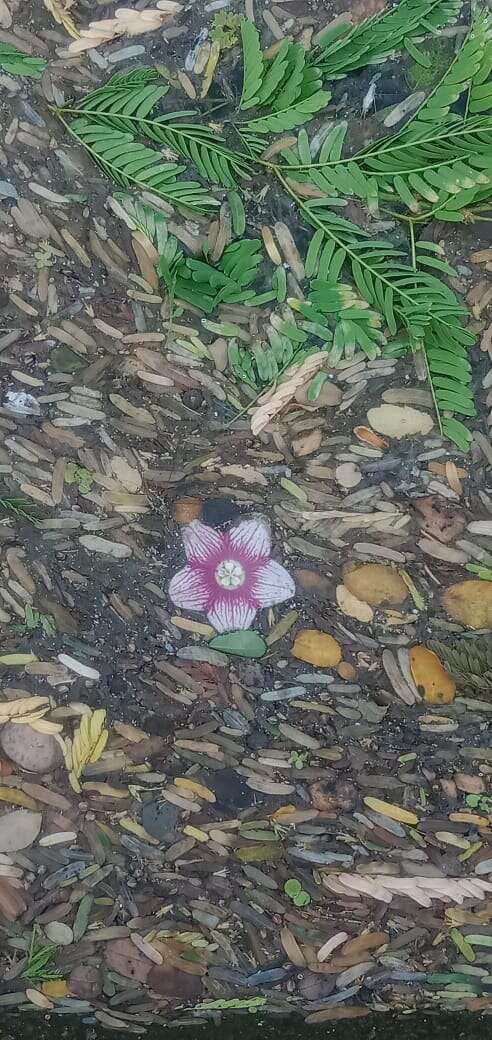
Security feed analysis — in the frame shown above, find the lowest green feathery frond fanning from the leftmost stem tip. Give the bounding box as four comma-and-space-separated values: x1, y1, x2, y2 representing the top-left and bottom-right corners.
69, 116, 218, 213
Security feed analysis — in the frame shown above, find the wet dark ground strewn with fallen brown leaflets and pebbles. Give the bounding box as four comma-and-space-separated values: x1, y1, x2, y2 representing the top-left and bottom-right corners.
0, 0, 492, 1035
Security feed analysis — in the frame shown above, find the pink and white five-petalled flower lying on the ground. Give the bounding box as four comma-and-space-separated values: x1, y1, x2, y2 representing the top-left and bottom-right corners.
169, 517, 295, 632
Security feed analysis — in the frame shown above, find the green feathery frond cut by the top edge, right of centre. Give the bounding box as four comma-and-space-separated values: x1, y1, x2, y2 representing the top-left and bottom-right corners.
309, 0, 461, 79
